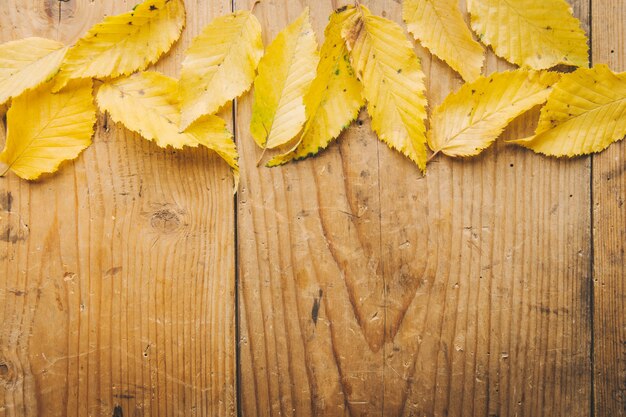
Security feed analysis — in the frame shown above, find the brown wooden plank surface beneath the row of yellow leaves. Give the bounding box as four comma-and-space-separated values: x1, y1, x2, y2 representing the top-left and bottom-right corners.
0, 0, 626, 417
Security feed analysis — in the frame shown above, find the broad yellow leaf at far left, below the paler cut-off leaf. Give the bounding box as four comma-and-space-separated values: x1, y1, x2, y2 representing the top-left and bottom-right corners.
0, 80, 96, 180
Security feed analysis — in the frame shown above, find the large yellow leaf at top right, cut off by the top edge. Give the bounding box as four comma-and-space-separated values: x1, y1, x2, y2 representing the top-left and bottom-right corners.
468, 0, 589, 69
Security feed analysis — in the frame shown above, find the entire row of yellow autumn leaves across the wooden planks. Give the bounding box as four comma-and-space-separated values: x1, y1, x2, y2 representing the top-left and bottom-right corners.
0, 0, 626, 183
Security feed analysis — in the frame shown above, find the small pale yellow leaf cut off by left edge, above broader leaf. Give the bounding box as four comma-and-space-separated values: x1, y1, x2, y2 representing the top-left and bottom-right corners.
0, 38, 67, 105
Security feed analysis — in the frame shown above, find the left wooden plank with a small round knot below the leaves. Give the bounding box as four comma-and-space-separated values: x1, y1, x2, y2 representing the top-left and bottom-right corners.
0, 0, 236, 417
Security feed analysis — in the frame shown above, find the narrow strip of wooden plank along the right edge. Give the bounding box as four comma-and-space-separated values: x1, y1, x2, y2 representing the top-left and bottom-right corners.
591, 0, 626, 417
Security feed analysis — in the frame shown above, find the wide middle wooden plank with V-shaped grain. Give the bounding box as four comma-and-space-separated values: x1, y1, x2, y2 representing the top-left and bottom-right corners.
237, 0, 591, 416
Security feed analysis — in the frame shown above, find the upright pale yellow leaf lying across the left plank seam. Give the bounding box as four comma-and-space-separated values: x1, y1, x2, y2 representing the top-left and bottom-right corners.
179, 11, 263, 130
